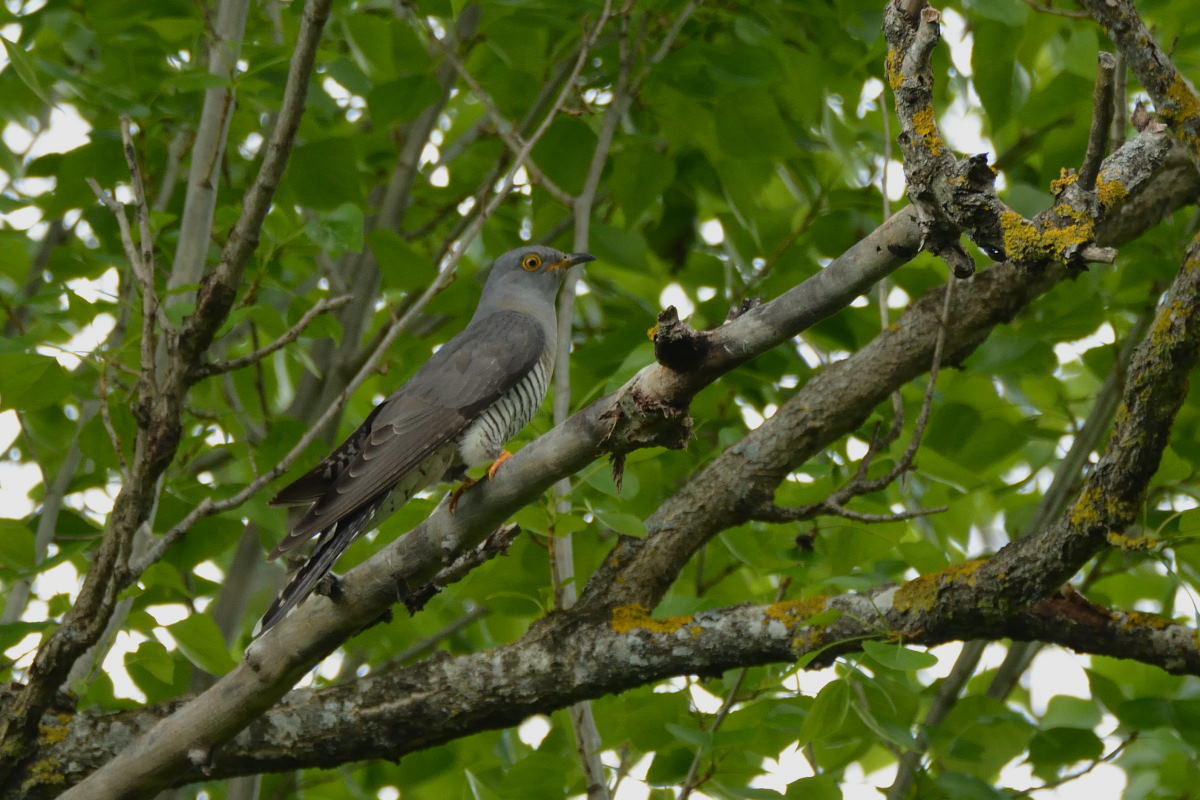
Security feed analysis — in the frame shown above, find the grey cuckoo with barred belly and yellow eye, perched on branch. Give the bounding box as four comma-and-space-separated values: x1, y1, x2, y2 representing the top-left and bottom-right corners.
259, 246, 595, 632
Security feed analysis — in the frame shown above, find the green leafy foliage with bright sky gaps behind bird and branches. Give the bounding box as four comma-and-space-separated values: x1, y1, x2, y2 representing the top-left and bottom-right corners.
0, 0, 1200, 799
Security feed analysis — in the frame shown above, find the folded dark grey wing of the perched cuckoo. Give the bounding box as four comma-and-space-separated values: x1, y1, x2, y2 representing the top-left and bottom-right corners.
268, 311, 545, 554
